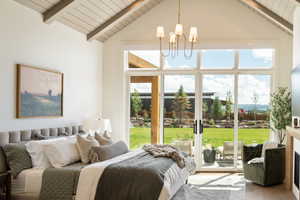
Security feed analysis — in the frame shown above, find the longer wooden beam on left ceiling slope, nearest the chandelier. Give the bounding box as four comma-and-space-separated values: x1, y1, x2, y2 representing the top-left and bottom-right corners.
87, 0, 145, 40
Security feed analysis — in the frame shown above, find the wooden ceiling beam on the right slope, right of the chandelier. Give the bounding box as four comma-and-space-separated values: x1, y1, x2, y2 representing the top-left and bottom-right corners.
240, 0, 292, 34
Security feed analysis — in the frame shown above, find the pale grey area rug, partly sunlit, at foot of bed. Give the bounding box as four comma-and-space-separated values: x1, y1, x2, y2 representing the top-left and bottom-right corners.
172, 174, 245, 200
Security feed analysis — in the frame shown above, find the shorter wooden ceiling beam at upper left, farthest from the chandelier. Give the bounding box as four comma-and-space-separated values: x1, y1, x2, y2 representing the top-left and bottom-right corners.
43, 0, 78, 23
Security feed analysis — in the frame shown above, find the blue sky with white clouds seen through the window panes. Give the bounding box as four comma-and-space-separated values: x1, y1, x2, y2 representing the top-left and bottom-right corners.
131, 49, 274, 104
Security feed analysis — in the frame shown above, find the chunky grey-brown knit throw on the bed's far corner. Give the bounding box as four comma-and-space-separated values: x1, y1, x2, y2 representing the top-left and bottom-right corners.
143, 144, 185, 169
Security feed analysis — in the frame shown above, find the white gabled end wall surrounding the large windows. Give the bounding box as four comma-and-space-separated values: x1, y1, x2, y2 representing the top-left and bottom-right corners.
103, 0, 292, 140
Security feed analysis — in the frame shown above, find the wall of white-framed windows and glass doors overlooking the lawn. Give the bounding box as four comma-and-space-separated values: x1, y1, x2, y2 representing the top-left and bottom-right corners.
127, 48, 275, 170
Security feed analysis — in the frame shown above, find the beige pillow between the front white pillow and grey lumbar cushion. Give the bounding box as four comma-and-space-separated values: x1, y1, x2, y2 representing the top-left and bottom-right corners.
76, 135, 100, 164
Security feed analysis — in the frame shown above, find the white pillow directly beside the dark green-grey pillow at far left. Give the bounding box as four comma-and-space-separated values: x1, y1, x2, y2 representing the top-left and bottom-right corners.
26, 138, 65, 168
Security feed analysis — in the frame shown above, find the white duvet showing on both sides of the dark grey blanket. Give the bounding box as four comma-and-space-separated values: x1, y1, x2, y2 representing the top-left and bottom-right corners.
76, 149, 189, 200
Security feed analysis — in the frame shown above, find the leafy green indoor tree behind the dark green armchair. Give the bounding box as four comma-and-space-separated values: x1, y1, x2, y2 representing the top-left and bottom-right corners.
271, 87, 292, 144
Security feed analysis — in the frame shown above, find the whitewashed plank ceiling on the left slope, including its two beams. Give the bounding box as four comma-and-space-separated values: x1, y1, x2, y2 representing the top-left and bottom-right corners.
15, 0, 162, 41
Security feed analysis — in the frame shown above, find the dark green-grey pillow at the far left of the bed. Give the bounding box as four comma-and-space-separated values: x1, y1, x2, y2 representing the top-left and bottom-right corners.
3, 144, 32, 178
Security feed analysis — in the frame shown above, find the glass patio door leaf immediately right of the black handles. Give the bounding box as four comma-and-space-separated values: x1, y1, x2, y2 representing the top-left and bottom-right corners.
199, 74, 235, 170
